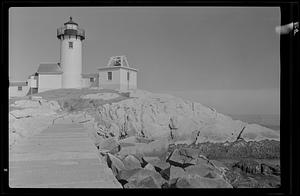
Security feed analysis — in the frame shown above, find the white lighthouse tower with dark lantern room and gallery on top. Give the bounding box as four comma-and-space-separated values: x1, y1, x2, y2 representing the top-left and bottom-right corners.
57, 17, 85, 88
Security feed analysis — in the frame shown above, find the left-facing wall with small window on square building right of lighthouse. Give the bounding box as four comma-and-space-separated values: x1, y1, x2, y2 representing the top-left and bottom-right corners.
99, 69, 120, 90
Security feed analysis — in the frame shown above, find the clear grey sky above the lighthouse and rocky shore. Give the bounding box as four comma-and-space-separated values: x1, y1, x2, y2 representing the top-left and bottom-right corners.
9, 7, 280, 114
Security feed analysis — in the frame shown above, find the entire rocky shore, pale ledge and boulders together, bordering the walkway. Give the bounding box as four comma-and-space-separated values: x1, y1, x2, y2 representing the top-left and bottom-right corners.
9, 91, 280, 188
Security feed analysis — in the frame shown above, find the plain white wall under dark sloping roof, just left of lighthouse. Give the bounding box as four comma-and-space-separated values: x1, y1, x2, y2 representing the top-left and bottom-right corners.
38, 74, 62, 92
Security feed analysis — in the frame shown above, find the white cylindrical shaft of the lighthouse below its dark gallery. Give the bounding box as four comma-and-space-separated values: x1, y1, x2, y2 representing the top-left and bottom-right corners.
60, 36, 82, 88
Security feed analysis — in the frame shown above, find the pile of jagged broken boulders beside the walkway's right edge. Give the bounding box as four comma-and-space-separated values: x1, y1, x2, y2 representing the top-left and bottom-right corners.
93, 136, 280, 188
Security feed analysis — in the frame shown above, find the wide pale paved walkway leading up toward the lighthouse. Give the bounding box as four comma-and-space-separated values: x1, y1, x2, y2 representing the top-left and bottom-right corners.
9, 124, 122, 188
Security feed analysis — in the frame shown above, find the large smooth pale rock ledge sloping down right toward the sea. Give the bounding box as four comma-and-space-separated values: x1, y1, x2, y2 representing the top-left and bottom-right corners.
93, 92, 280, 143
